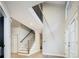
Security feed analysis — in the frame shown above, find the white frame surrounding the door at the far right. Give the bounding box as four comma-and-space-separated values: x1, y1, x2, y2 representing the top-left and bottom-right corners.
65, 11, 79, 57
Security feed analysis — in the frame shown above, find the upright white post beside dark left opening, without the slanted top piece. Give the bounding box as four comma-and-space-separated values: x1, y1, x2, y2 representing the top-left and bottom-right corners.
4, 17, 11, 58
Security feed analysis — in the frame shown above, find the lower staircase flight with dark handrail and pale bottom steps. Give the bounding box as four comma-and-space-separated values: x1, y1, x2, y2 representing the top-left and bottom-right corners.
18, 30, 35, 56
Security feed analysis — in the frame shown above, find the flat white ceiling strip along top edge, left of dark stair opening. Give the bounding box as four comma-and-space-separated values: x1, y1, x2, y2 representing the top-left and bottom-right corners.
5, 1, 43, 7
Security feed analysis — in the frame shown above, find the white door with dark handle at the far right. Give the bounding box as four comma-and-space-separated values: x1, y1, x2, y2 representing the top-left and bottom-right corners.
68, 19, 78, 57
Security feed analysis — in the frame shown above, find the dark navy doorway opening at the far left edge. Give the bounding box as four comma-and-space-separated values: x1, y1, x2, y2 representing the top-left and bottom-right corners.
0, 7, 4, 58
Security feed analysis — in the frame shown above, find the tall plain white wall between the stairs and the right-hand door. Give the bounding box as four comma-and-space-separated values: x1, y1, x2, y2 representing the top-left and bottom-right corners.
43, 3, 65, 56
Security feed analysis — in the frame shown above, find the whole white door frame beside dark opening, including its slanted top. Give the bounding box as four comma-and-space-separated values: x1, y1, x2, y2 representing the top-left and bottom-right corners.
0, 1, 11, 58
